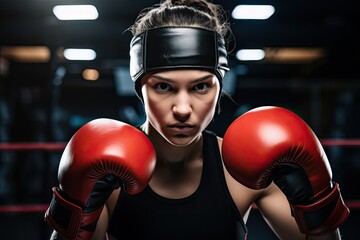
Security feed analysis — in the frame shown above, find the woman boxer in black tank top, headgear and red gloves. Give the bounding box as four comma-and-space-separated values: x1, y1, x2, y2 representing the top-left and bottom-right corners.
45, 0, 348, 240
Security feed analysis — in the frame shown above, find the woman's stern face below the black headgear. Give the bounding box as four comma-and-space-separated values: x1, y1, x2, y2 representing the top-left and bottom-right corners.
142, 70, 220, 146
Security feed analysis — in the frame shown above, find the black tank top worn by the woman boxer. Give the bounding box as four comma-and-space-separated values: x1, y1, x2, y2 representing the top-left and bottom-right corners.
108, 131, 247, 240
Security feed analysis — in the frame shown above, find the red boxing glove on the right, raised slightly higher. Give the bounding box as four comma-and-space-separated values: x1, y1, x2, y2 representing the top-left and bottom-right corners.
222, 107, 349, 235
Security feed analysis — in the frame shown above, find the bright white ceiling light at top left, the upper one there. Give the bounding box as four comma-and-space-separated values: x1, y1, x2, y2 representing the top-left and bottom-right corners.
53, 5, 99, 20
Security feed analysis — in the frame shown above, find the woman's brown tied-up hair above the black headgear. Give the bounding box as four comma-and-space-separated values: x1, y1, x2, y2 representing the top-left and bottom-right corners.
129, 0, 235, 113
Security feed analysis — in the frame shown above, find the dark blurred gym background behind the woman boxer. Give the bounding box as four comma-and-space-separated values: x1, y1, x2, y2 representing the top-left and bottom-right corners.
0, 0, 360, 240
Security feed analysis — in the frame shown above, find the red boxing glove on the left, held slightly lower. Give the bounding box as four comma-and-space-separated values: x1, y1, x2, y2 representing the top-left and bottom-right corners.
45, 119, 156, 239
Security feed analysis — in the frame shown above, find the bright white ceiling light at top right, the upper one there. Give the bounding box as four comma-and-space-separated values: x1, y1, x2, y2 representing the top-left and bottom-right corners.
231, 5, 275, 20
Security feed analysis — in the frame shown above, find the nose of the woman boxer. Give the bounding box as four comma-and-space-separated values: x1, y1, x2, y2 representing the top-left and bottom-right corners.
172, 92, 192, 122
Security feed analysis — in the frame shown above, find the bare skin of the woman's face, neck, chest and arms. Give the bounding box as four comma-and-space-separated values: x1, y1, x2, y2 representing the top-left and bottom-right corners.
50, 70, 340, 240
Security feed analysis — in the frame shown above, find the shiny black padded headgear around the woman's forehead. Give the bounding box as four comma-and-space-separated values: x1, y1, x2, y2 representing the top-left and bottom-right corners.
130, 27, 229, 98
